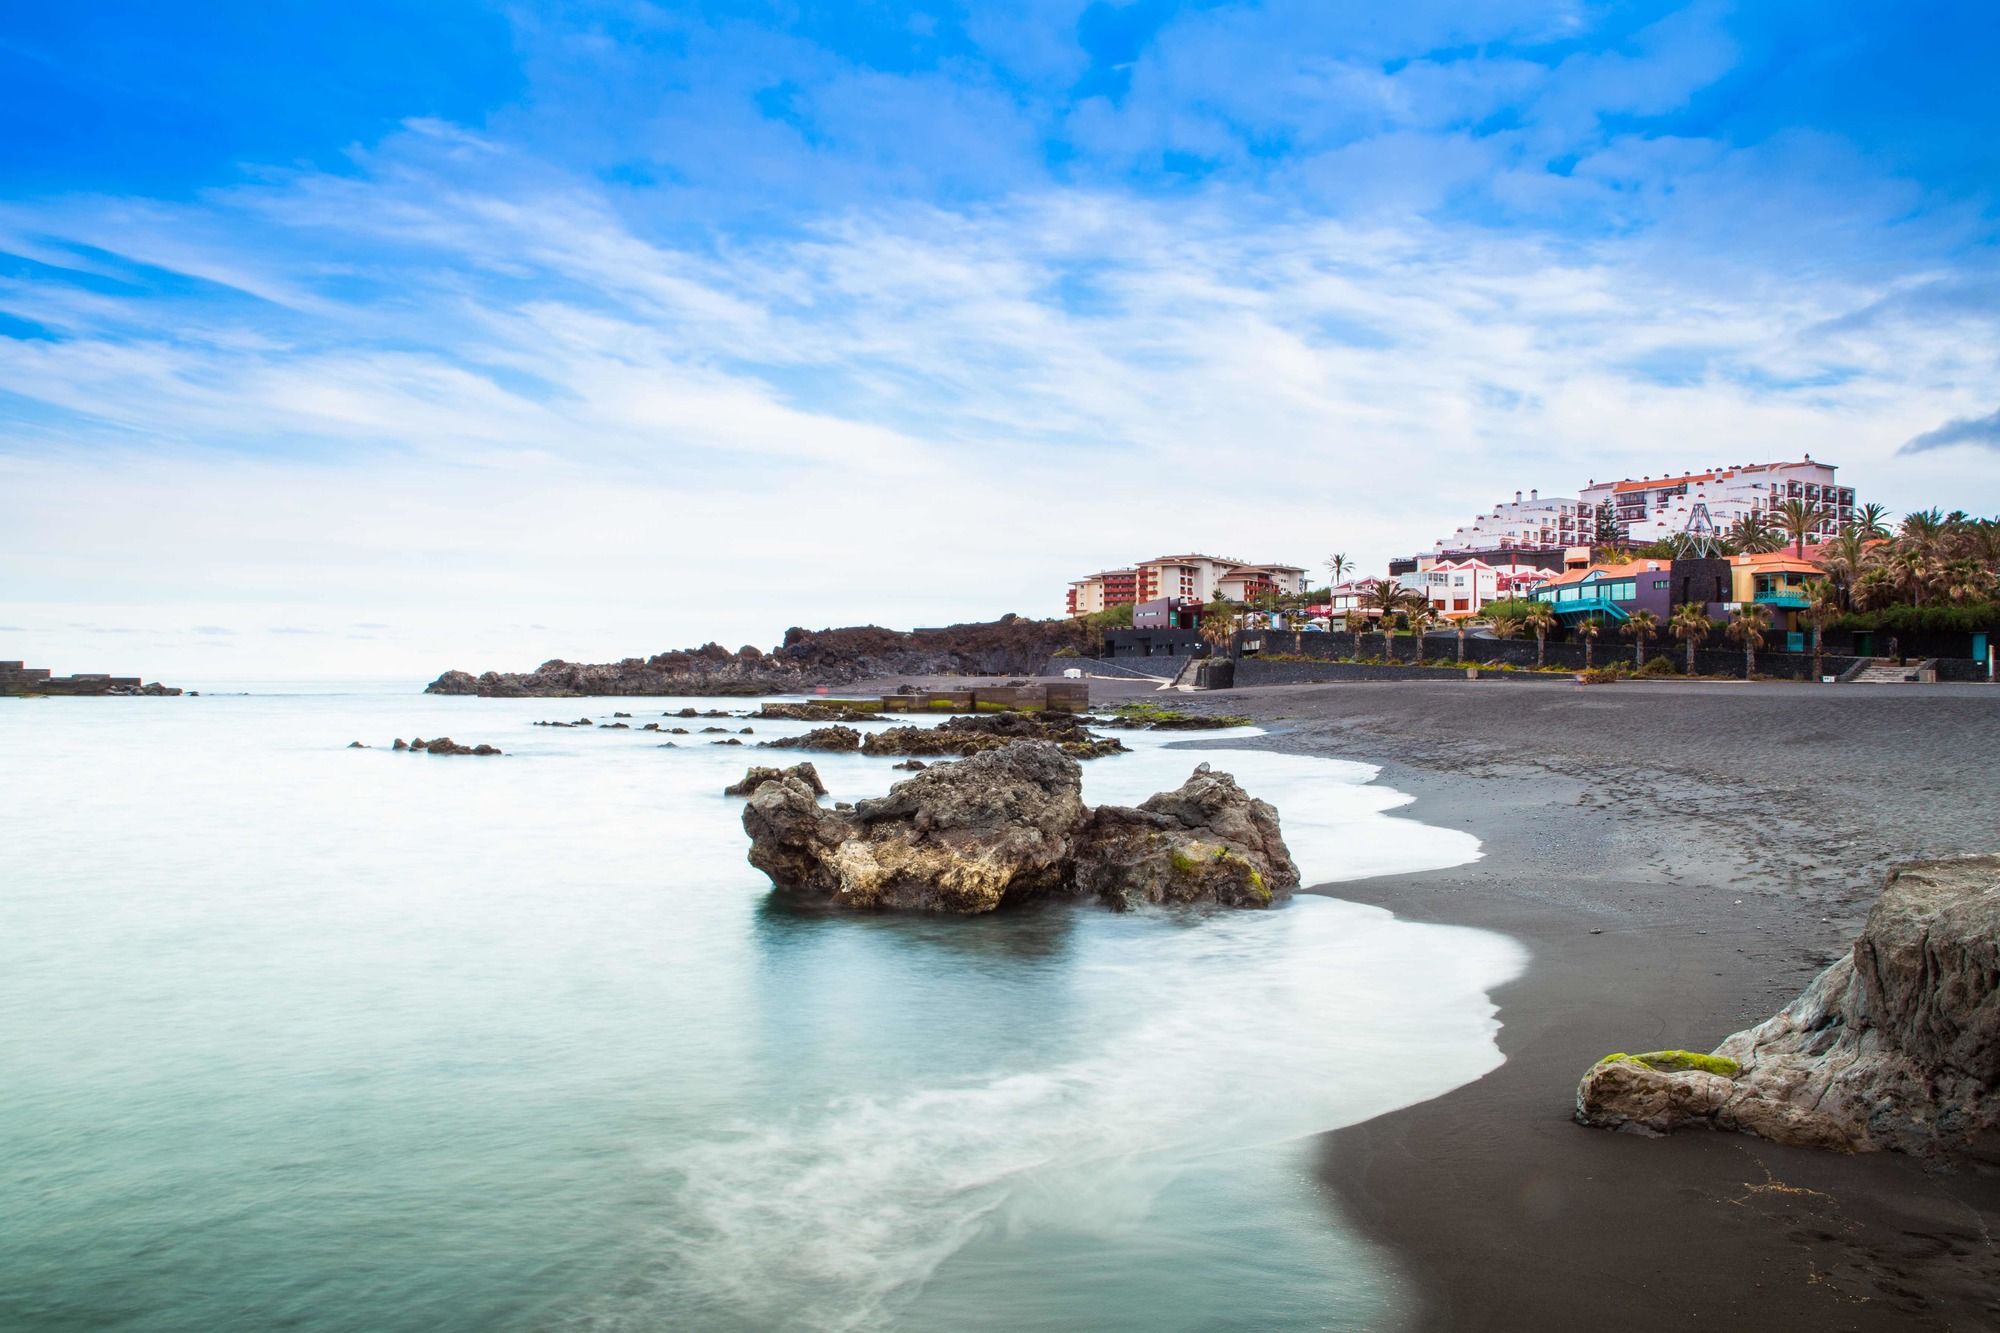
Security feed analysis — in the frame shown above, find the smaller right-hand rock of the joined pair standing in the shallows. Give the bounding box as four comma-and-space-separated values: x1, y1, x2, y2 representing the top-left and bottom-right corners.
1076, 765, 1298, 911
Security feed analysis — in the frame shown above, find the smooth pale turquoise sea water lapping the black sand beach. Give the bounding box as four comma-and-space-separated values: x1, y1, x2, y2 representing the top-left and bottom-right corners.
0, 687, 1520, 1331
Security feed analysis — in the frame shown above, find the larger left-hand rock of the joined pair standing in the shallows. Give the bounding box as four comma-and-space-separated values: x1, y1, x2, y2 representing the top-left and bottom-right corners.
744, 741, 1086, 913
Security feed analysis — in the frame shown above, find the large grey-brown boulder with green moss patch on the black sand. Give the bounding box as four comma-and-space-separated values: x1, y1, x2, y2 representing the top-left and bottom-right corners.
1576, 855, 2000, 1161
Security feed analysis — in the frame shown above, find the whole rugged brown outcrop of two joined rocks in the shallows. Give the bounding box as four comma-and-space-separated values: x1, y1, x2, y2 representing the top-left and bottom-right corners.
744, 741, 1298, 913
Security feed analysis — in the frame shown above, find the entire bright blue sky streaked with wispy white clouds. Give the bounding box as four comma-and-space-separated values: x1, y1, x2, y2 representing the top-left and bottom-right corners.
0, 0, 2000, 668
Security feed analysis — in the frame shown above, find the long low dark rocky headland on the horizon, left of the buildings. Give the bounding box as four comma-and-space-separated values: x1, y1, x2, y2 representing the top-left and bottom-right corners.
424, 614, 1080, 696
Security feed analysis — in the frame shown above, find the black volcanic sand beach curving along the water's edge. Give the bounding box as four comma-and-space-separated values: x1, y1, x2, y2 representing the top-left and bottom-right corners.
1176, 683, 2000, 1329
